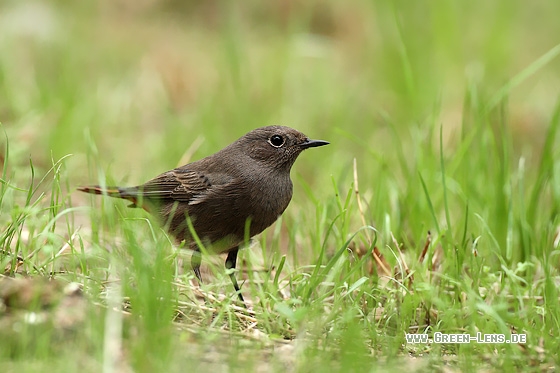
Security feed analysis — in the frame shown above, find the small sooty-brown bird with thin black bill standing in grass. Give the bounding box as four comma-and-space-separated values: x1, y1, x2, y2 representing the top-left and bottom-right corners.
78, 126, 328, 302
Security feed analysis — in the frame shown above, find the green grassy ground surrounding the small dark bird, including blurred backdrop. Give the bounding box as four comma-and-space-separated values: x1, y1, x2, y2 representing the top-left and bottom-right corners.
0, 0, 560, 372
